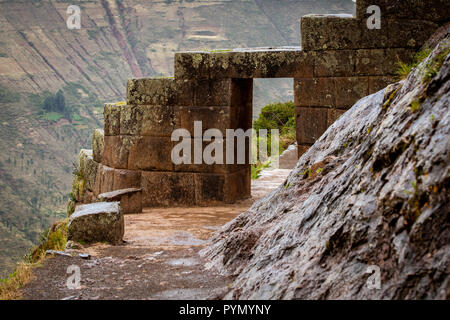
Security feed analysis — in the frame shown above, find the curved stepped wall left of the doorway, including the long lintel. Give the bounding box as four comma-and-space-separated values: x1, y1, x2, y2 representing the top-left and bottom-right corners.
100, 47, 312, 207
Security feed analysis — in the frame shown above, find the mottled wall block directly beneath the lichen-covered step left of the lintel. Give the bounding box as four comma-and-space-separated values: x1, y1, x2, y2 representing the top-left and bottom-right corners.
120, 105, 180, 137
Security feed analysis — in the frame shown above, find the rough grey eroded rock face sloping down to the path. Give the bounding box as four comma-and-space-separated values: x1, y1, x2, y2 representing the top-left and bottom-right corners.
202, 36, 450, 299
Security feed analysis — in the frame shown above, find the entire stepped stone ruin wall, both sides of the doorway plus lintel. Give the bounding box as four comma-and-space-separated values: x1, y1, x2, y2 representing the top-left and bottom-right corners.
69, 0, 449, 211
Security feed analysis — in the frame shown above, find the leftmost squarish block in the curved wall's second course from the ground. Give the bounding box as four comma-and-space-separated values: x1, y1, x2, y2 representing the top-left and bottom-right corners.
102, 136, 134, 169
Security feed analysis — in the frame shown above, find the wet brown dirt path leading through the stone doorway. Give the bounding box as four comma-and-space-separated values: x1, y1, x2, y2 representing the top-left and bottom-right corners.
22, 169, 290, 299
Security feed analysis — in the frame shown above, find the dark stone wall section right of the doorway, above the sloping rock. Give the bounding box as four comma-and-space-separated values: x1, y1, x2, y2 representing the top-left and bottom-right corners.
294, 0, 450, 156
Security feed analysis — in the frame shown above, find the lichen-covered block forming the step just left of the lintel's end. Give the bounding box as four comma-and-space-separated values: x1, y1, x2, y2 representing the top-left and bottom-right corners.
127, 78, 194, 106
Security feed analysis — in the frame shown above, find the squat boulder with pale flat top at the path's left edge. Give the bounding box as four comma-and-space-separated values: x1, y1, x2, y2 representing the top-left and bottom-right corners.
68, 202, 125, 244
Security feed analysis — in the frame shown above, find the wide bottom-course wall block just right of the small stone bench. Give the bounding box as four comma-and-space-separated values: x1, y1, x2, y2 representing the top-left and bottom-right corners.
141, 172, 195, 207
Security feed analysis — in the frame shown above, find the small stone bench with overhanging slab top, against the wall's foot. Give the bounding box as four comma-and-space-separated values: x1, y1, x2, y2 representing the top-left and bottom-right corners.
98, 188, 142, 214
